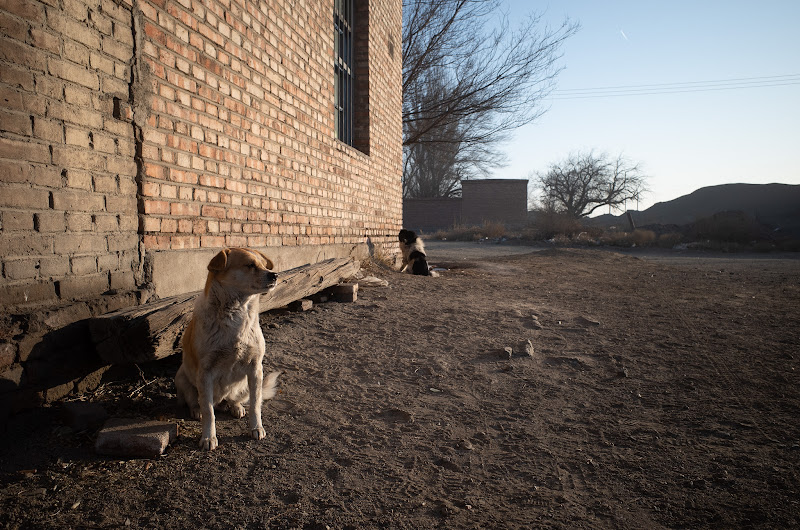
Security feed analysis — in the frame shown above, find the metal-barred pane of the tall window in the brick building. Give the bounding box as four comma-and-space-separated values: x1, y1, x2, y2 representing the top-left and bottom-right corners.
333, 0, 353, 145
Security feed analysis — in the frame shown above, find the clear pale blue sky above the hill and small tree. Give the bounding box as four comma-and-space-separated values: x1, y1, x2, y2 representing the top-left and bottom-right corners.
500, 0, 800, 213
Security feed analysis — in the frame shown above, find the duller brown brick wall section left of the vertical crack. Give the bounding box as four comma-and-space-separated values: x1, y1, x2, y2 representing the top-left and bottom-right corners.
0, 0, 139, 310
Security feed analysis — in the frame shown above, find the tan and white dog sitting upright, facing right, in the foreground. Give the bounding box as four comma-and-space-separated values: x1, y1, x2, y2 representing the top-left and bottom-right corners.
175, 248, 280, 450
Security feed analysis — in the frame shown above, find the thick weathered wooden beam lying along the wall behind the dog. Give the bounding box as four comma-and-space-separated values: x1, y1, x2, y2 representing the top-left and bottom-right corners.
89, 258, 359, 364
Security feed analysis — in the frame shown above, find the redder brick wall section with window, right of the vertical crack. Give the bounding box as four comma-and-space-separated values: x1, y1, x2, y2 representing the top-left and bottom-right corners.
134, 0, 401, 254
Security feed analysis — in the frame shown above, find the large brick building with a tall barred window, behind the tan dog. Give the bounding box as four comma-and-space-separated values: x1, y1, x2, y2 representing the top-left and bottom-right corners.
0, 0, 402, 412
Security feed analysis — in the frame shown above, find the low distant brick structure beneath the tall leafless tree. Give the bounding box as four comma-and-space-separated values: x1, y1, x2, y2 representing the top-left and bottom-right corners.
403, 179, 528, 233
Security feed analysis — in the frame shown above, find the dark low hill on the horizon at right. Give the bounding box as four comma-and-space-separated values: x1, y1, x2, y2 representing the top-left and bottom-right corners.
589, 184, 800, 234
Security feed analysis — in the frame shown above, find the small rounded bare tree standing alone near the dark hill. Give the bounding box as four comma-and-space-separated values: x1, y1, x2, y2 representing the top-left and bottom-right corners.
536, 152, 647, 218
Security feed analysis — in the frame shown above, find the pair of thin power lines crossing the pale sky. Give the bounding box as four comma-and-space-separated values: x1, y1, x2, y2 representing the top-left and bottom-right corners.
548, 74, 800, 99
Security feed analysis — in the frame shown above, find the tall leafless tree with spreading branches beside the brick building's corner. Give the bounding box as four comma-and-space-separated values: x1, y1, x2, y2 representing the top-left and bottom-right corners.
403, 0, 578, 197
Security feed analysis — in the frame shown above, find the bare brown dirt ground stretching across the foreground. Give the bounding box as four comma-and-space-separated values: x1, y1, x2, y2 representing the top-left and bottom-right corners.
0, 242, 800, 529
